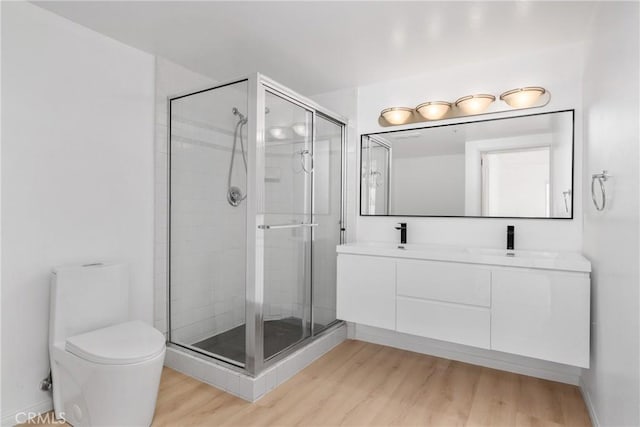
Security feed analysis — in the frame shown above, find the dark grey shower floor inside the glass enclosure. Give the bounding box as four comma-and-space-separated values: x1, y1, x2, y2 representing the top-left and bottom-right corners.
191, 317, 323, 363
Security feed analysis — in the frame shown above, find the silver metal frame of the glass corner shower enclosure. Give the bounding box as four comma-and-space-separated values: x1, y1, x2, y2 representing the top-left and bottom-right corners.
166, 73, 348, 376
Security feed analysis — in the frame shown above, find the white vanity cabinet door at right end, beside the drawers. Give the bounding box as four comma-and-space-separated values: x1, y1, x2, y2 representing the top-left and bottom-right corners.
491, 269, 590, 368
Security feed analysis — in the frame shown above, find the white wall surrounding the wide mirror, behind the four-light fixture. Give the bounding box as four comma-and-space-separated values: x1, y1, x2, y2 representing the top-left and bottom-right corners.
356, 45, 583, 251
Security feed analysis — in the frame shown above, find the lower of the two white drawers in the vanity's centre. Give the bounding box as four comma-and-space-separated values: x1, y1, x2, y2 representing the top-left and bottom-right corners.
396, 297, 491, 348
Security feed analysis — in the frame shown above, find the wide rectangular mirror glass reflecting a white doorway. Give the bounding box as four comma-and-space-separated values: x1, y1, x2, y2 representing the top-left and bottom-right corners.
360, 110, 574, 219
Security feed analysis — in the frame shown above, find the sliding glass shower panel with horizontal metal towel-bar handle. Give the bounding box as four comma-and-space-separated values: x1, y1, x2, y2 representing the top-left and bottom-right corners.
259, 90, 314, 360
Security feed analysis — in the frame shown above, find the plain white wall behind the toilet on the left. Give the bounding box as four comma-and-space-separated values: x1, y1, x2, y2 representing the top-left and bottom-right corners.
2, 2, 154, 424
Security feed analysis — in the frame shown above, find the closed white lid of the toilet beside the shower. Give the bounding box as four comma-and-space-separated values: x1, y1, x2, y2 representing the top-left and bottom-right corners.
65, 320, 165, 365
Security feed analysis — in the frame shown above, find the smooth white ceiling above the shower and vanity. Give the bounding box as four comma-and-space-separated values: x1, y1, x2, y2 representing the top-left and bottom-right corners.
34, 0, 597, 95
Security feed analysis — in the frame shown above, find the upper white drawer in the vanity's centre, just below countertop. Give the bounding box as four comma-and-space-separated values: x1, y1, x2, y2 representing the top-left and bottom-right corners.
397, 260, 491, 307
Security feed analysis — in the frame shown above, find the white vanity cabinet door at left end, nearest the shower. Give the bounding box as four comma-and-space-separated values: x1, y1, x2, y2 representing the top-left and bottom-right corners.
337, 254, 396, 329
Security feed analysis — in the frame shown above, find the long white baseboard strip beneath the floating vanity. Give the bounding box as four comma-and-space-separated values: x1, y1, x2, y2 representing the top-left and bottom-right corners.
348, 324, 582, 385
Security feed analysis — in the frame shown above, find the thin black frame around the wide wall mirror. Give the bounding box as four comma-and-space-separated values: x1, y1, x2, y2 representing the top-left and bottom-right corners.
358, 108, 576, 220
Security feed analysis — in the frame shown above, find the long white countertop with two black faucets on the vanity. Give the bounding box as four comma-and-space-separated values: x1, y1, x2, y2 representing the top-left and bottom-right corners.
336, 242, 591, 273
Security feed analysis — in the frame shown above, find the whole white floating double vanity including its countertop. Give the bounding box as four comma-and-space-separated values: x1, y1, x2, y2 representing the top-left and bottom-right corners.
337, 243, 591, 368
